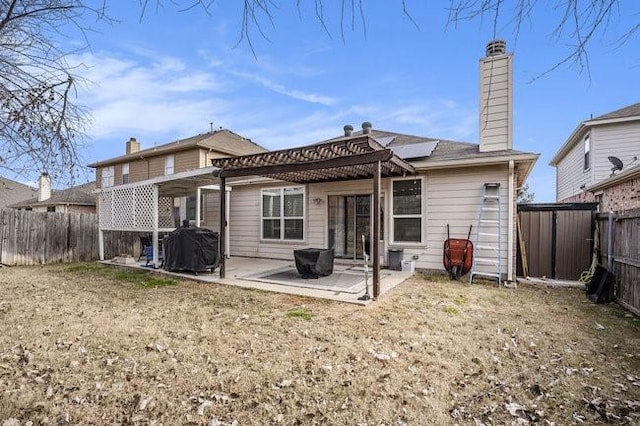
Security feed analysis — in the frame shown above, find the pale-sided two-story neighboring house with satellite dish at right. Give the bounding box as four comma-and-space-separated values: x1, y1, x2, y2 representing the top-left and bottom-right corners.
550, 103, 640, 202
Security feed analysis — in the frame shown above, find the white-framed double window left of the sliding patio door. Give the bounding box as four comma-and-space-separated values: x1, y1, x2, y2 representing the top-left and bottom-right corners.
262, 186, 304, 240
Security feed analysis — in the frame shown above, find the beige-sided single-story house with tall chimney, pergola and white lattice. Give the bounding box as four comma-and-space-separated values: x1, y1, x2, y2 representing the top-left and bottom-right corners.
92, 41, 538, 297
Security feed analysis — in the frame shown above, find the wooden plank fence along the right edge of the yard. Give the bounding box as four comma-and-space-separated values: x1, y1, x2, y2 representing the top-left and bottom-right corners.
596, 209, 640, 315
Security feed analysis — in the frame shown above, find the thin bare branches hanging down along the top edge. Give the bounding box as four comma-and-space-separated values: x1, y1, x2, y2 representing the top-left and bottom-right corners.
138, 0, 640, 73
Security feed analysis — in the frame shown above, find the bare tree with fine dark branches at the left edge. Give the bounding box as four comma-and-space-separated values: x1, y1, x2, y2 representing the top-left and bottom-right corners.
0, 0, 102, 183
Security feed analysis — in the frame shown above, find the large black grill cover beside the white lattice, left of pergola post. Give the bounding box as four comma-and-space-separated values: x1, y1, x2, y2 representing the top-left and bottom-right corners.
163, 226, 220, 272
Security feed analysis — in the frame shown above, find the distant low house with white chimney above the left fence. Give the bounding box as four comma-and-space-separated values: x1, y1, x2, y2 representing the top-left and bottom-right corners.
8, 173, 96, 213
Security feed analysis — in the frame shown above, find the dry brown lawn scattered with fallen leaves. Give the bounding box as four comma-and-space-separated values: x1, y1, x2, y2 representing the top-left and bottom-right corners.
0, 264, 640, 426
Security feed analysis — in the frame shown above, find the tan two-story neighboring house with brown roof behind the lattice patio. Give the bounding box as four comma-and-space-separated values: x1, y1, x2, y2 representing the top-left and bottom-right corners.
89, 129, 266, 226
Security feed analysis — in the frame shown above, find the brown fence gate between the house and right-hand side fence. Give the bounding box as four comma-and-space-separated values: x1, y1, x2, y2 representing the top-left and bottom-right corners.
517, 203, 597, 280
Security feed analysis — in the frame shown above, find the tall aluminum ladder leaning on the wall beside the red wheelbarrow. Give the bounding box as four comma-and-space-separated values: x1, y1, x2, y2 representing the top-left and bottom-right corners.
469, 183, 502, 286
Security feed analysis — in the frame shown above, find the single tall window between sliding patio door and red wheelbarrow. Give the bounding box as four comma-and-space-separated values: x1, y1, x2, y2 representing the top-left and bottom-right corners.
392, 179, 422, 243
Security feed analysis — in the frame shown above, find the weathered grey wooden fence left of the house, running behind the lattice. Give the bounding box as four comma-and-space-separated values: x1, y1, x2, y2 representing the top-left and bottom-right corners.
0, 209, 140, 266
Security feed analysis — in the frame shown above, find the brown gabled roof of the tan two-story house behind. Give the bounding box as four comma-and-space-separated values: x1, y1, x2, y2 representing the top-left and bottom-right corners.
89, 129, 266, 167
